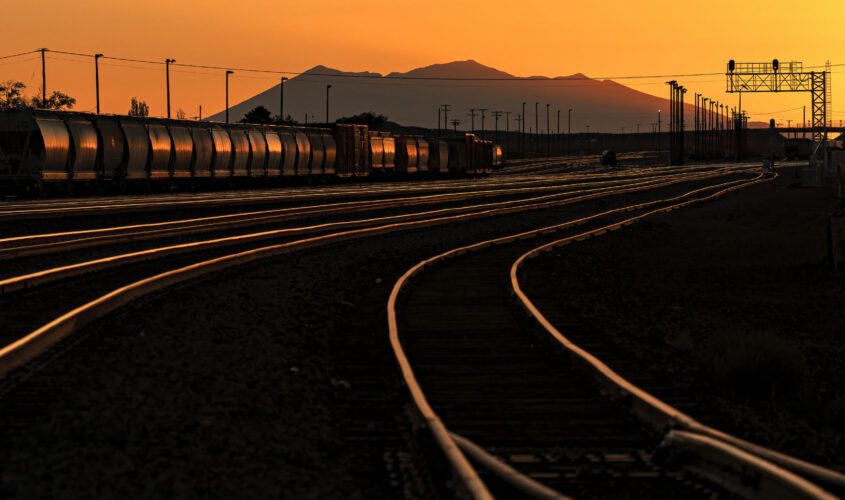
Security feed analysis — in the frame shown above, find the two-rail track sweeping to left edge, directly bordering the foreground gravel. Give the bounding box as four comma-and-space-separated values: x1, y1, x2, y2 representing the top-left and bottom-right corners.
0, 164, 752, 375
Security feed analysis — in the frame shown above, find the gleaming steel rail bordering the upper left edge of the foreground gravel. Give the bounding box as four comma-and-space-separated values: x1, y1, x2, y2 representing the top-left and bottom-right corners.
0, 166, 744, 380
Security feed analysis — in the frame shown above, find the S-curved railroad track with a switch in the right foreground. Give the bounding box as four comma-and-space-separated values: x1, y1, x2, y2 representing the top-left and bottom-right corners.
387, 171, 843, 498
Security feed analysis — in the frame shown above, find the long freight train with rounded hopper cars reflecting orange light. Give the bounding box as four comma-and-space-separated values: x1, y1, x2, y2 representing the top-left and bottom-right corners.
0, 110, 502, 194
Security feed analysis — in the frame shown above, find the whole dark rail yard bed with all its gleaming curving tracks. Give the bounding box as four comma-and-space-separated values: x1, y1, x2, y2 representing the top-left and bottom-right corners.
0, 147, 845, 498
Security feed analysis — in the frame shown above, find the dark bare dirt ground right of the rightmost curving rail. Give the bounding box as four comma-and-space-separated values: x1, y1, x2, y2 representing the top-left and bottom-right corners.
525, 174, 845, 468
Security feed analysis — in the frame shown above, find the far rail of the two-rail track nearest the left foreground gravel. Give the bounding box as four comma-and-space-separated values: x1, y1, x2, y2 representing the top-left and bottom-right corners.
0, 171, 736, 295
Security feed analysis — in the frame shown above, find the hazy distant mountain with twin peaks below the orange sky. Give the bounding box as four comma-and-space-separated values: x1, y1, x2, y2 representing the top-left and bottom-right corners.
209, 60, 740, 133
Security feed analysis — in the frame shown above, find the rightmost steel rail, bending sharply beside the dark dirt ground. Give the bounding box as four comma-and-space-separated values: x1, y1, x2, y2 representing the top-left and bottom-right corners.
510, 175, 845, 498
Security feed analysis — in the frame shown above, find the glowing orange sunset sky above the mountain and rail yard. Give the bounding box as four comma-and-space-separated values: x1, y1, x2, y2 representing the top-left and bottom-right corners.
0, 0, 845, 127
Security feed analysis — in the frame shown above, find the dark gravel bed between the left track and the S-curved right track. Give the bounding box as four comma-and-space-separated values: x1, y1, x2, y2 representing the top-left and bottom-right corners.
0, 182, 692, 498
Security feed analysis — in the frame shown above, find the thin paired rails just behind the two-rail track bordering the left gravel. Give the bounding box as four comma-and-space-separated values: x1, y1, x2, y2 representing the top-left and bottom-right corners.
0, 168, 732, 260
